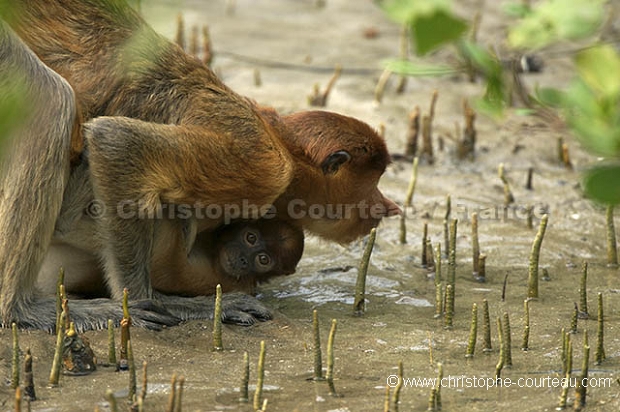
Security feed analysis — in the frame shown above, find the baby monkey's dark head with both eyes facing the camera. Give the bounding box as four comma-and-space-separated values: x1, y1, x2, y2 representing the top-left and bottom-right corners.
218, 219, 303, 280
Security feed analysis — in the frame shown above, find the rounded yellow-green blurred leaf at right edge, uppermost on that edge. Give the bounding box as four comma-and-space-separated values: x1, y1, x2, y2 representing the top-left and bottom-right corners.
575, 45, 620, 97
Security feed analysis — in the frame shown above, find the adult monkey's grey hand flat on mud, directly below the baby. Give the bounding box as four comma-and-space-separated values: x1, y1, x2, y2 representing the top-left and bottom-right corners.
156, 292, 273, 326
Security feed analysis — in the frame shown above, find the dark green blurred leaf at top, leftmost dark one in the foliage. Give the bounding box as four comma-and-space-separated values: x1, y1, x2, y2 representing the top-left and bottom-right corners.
411, 9, 467, 55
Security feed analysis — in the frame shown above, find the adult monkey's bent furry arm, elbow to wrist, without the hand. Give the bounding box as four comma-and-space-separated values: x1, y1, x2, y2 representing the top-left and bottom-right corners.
84, 117, 292, 299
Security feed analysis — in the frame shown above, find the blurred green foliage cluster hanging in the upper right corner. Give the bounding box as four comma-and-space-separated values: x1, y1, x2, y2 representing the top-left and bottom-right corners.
379, 0, 620, 204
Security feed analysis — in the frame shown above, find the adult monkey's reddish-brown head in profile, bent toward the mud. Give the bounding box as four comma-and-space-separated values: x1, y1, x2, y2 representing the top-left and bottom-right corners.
283, 111, 402, 243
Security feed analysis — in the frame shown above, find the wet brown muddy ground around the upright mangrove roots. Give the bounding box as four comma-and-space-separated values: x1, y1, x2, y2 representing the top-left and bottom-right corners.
0, 0, 620, 411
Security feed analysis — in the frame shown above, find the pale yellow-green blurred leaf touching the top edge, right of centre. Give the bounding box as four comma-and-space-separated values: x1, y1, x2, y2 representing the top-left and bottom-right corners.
508, 0, 604, 49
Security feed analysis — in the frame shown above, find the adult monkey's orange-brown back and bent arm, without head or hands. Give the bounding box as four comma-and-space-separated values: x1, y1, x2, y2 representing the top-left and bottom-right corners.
7, 0, 292, 306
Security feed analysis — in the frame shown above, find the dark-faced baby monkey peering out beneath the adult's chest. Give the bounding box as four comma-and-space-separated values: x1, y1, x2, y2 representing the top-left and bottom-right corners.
151, 219, 304, 296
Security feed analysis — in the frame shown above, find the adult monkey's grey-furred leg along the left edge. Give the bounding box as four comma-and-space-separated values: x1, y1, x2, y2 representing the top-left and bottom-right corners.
0, 20, 77, 325
